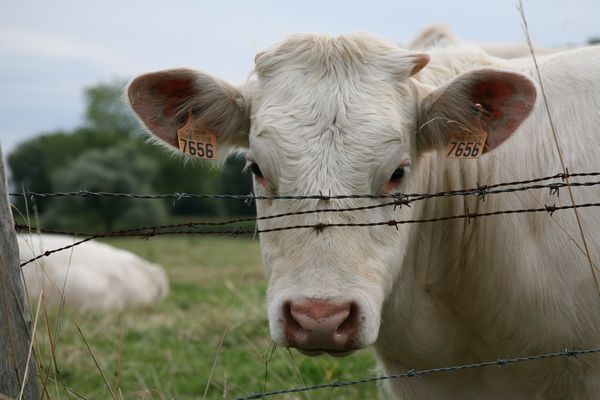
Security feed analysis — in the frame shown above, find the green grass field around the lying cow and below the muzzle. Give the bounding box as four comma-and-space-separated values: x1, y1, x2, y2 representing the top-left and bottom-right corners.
31, 236, 376, 400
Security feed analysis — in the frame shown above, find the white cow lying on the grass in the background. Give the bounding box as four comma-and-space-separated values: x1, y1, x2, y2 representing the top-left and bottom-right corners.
17, 235, 169, 311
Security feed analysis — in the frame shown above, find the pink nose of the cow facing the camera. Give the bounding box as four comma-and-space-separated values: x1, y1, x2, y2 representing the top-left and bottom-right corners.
284, 299, 359, 353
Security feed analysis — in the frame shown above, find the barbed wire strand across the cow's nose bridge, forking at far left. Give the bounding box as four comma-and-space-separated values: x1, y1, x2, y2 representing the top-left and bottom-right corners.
15, 202, 600, 267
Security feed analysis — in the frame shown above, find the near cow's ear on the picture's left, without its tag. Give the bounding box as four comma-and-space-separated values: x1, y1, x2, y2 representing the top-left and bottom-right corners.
127, 69, 250, 156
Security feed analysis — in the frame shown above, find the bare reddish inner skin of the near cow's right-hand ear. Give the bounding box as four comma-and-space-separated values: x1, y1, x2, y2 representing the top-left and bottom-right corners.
469, 71, 536, 151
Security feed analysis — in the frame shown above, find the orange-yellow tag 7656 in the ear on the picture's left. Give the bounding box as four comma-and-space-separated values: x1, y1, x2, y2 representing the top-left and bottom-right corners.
177, 110, 217, 160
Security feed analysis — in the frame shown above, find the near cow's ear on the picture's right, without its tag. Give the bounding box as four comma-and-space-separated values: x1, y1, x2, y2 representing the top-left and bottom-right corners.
417, 69, 537, 153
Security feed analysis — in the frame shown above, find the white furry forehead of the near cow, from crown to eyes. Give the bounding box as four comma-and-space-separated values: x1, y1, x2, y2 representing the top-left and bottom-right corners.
245, 35, 416, 190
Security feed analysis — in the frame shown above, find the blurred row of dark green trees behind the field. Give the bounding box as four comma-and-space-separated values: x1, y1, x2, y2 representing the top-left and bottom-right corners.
8, 81, 254, 227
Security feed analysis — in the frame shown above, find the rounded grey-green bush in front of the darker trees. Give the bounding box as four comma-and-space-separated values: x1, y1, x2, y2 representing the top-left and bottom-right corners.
43, 143, 167, 232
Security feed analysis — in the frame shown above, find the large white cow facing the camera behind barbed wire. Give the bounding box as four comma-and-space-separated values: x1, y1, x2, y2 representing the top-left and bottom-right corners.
128, 34, 600, 399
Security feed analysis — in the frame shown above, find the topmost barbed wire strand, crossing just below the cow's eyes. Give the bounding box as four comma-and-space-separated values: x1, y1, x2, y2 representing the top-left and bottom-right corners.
10, 172, 600, 202
